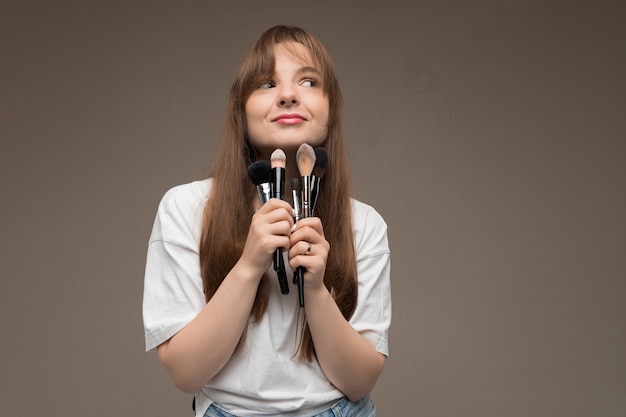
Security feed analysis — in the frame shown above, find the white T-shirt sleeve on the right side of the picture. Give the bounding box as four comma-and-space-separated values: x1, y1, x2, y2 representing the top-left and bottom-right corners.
350, 200, 392, 356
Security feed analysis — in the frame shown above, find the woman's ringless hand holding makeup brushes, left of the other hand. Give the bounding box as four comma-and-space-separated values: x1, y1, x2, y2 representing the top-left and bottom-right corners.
239, 198, 295, 279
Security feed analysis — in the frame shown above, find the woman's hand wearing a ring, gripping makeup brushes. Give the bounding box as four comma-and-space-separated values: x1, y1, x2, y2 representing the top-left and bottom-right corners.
289, 217, 330, 288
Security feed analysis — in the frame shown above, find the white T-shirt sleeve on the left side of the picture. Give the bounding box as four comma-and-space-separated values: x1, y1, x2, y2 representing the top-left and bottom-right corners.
143, 180, 209, 351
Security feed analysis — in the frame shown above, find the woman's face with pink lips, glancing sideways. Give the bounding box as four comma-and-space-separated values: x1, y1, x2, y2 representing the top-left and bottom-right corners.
245, 42, 329, 157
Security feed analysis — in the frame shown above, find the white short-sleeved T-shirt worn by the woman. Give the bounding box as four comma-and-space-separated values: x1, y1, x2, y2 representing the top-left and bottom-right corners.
143, 179, 391, 417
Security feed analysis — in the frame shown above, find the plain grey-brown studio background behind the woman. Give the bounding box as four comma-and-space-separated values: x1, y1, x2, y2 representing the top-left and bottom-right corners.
0, 0, 626, 417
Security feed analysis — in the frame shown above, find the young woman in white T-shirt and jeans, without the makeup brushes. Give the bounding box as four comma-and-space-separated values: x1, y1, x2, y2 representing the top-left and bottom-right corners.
143, 26, 391, 417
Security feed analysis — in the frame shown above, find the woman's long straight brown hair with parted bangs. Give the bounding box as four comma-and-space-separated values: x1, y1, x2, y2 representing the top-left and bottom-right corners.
200, 26, 357, 361
